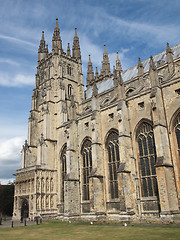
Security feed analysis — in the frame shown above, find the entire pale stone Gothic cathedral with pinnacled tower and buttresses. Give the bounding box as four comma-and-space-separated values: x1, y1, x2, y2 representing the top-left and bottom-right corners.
13, 19, 180, 221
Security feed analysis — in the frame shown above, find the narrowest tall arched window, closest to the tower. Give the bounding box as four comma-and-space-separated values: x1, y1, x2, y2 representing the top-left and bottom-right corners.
60, 145, 67, 202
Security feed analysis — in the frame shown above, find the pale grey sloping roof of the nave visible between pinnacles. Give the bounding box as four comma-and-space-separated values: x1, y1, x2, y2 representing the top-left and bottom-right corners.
86, 44, 180, 99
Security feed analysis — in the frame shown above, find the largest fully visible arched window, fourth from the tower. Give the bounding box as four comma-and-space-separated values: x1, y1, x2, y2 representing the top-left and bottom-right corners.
137, 122, 158, 197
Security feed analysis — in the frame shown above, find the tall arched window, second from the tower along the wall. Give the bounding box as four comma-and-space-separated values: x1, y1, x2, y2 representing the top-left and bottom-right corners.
81, 139, 92, 200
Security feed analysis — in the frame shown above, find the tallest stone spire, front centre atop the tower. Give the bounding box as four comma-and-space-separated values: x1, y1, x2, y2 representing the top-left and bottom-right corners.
52, 18, 62, 53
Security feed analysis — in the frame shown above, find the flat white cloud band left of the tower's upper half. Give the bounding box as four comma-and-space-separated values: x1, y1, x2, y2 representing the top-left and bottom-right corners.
0, 72, 35, 87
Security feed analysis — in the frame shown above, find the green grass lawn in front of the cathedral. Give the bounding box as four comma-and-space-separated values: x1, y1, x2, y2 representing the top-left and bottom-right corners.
0, 220, 180, 240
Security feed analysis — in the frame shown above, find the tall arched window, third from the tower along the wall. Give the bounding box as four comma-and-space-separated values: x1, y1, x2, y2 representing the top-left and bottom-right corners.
106, 131, 120, 199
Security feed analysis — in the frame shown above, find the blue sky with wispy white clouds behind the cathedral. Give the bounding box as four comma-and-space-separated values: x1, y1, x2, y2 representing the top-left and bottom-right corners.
0, 0, 180, 184
